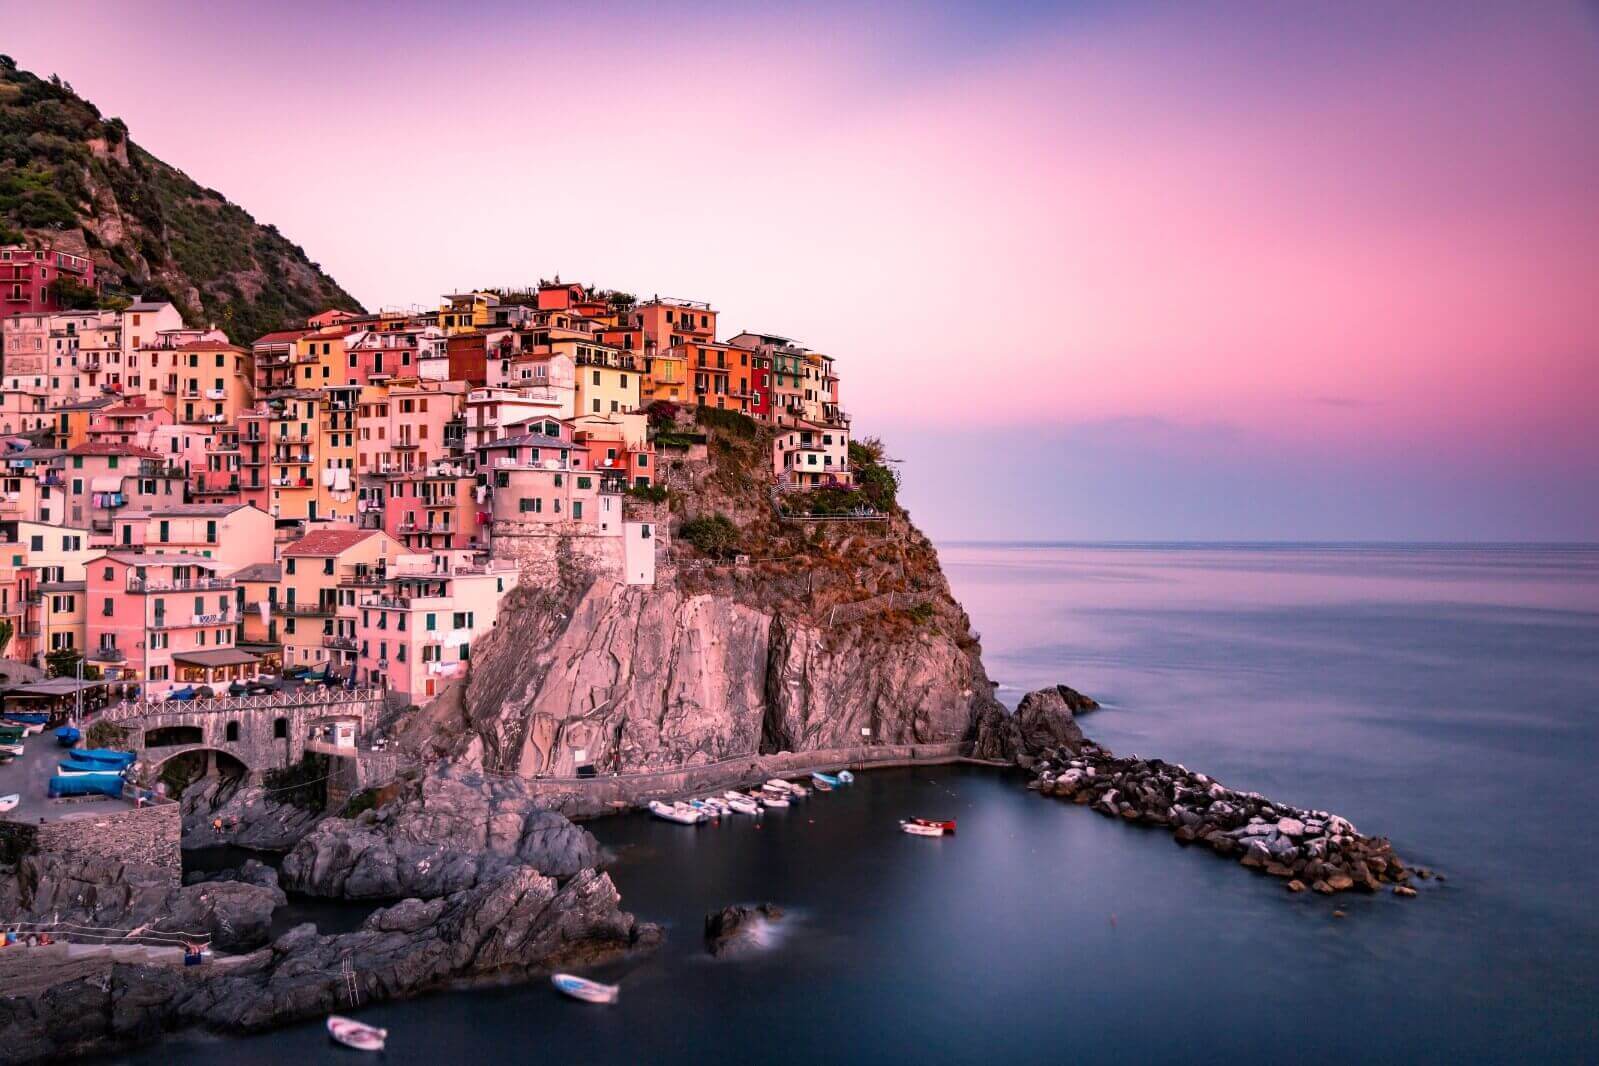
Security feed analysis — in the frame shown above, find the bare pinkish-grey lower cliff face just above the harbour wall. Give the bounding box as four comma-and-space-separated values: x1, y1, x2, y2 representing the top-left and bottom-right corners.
438, 562, 998, 777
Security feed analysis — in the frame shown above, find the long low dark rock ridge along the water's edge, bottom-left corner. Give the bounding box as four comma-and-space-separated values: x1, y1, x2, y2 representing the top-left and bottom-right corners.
0, 866, 660, 1061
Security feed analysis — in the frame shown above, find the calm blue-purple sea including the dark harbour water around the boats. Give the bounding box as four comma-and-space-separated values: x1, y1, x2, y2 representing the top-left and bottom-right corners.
138, 545, 1599, 1066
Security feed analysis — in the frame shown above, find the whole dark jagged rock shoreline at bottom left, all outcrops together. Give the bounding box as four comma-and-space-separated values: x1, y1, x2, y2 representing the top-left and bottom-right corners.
0, 767, 662, 1063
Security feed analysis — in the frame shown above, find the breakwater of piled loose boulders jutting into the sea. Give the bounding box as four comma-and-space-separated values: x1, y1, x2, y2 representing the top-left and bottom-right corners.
1010, 689, 1410, 895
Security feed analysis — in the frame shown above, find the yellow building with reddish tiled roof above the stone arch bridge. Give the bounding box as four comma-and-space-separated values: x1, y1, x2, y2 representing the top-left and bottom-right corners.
278, 529, 405, 668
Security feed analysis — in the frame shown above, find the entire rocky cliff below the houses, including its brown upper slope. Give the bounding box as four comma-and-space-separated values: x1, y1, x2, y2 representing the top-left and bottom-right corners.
413, 416, 998, 777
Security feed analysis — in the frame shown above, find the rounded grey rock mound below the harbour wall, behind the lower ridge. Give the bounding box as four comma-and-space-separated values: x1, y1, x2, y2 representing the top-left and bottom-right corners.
281, 767, 603, 900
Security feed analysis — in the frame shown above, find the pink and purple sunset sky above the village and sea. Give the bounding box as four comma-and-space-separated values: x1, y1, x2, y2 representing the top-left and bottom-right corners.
3, 0, 1599, 540
